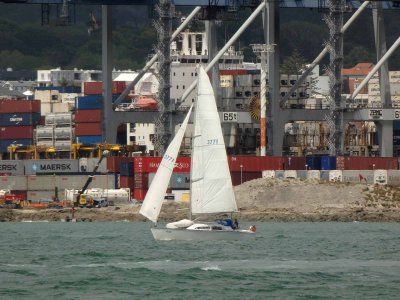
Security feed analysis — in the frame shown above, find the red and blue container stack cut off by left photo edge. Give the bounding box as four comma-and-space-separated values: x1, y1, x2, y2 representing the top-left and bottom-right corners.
0, 100, 40, 153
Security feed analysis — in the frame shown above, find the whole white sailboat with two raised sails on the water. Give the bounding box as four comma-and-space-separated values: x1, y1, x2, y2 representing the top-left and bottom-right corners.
140, 67, 256, 240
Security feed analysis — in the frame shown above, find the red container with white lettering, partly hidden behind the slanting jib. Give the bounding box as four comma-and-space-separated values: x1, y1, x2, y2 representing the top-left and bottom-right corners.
133, 156, 190, 173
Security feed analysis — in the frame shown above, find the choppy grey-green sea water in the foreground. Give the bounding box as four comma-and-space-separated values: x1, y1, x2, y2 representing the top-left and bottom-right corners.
0, 222, 400, 300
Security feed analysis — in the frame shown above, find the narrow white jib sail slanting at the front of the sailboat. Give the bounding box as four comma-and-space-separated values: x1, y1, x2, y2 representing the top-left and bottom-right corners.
139, 105, 193, 222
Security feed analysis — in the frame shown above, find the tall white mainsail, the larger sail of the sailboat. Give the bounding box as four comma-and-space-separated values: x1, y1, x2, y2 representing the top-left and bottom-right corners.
190, 68, 237, 214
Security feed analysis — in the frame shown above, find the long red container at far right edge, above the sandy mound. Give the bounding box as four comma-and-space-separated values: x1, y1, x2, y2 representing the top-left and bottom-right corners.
336, 156, 399, 170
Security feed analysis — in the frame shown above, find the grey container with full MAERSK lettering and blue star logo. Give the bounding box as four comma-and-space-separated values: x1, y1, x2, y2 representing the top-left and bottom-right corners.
24, 159, 79, 175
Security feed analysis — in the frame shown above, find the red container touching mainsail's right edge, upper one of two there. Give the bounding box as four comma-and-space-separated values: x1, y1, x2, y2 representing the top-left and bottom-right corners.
228, 156, 283, 172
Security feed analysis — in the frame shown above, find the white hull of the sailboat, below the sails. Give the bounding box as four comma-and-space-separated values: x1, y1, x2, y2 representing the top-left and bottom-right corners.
151, 228, 255, 241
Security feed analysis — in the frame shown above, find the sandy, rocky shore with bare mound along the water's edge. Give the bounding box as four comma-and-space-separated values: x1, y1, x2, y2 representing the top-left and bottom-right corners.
0, 179, 400, 222
